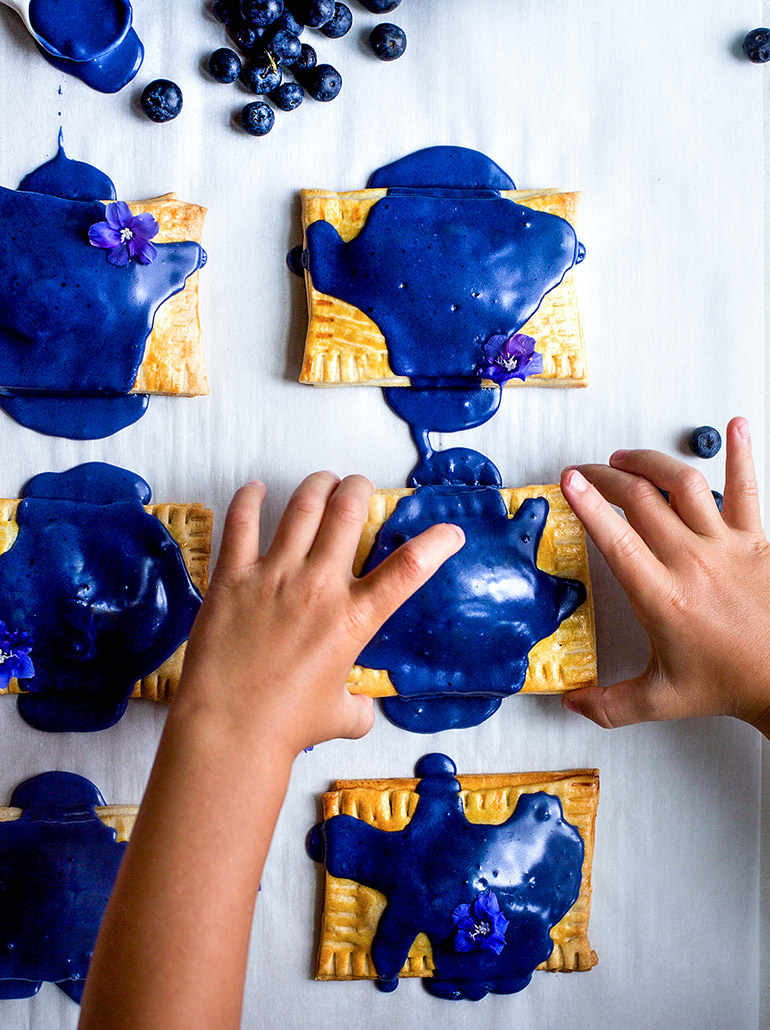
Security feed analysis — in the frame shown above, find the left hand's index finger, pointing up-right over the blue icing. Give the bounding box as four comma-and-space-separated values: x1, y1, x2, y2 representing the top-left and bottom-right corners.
353, 522, 465, 640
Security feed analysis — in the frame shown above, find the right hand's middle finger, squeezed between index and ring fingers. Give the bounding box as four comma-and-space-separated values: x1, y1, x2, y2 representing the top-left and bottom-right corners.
578, 465, 688, 561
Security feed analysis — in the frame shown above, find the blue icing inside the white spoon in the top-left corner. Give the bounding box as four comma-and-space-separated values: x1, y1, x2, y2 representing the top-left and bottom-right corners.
29, 0, 132, 62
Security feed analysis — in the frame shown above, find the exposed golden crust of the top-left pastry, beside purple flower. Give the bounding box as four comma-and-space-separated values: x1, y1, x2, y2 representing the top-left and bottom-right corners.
129, 194, 209, 397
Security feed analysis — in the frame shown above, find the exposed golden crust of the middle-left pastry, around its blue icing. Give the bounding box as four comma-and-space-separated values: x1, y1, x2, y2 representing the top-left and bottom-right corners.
0, 500, 214, 703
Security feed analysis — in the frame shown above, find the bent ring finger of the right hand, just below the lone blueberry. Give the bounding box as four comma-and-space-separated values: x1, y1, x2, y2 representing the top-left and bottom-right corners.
609, 450, 725, 537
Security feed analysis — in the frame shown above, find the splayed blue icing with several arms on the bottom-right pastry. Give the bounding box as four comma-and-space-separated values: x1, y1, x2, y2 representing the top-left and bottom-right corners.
308, 754, 584, 1000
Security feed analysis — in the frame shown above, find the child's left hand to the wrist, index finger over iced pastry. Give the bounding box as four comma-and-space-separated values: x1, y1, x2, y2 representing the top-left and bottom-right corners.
176, 472, 464, 757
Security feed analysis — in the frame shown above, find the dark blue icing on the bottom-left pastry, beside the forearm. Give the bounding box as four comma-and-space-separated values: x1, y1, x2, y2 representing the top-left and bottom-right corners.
0, 773, 126, 1001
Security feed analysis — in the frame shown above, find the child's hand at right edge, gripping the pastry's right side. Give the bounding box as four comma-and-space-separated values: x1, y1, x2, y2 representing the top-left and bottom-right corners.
562, 418, 770, 735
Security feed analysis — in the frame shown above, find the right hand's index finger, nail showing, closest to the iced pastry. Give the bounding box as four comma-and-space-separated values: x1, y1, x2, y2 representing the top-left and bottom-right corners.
561, 469, 668, 605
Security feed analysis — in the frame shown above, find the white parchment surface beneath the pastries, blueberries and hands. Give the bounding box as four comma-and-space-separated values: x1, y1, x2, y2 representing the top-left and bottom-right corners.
0, 0, 766, 1030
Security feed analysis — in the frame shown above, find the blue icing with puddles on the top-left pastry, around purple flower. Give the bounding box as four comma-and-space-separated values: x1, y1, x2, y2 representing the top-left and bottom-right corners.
0, 143, 205, 440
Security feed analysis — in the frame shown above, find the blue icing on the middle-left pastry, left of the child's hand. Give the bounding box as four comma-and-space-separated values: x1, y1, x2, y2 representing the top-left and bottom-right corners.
0, 462, 201, 731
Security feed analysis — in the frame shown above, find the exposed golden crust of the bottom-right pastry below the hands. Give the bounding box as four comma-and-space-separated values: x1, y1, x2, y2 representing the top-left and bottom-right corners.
315, 769, 599, 980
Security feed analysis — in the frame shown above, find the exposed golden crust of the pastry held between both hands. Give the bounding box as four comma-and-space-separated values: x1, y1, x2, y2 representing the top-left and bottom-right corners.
348, 485, 597, 697
